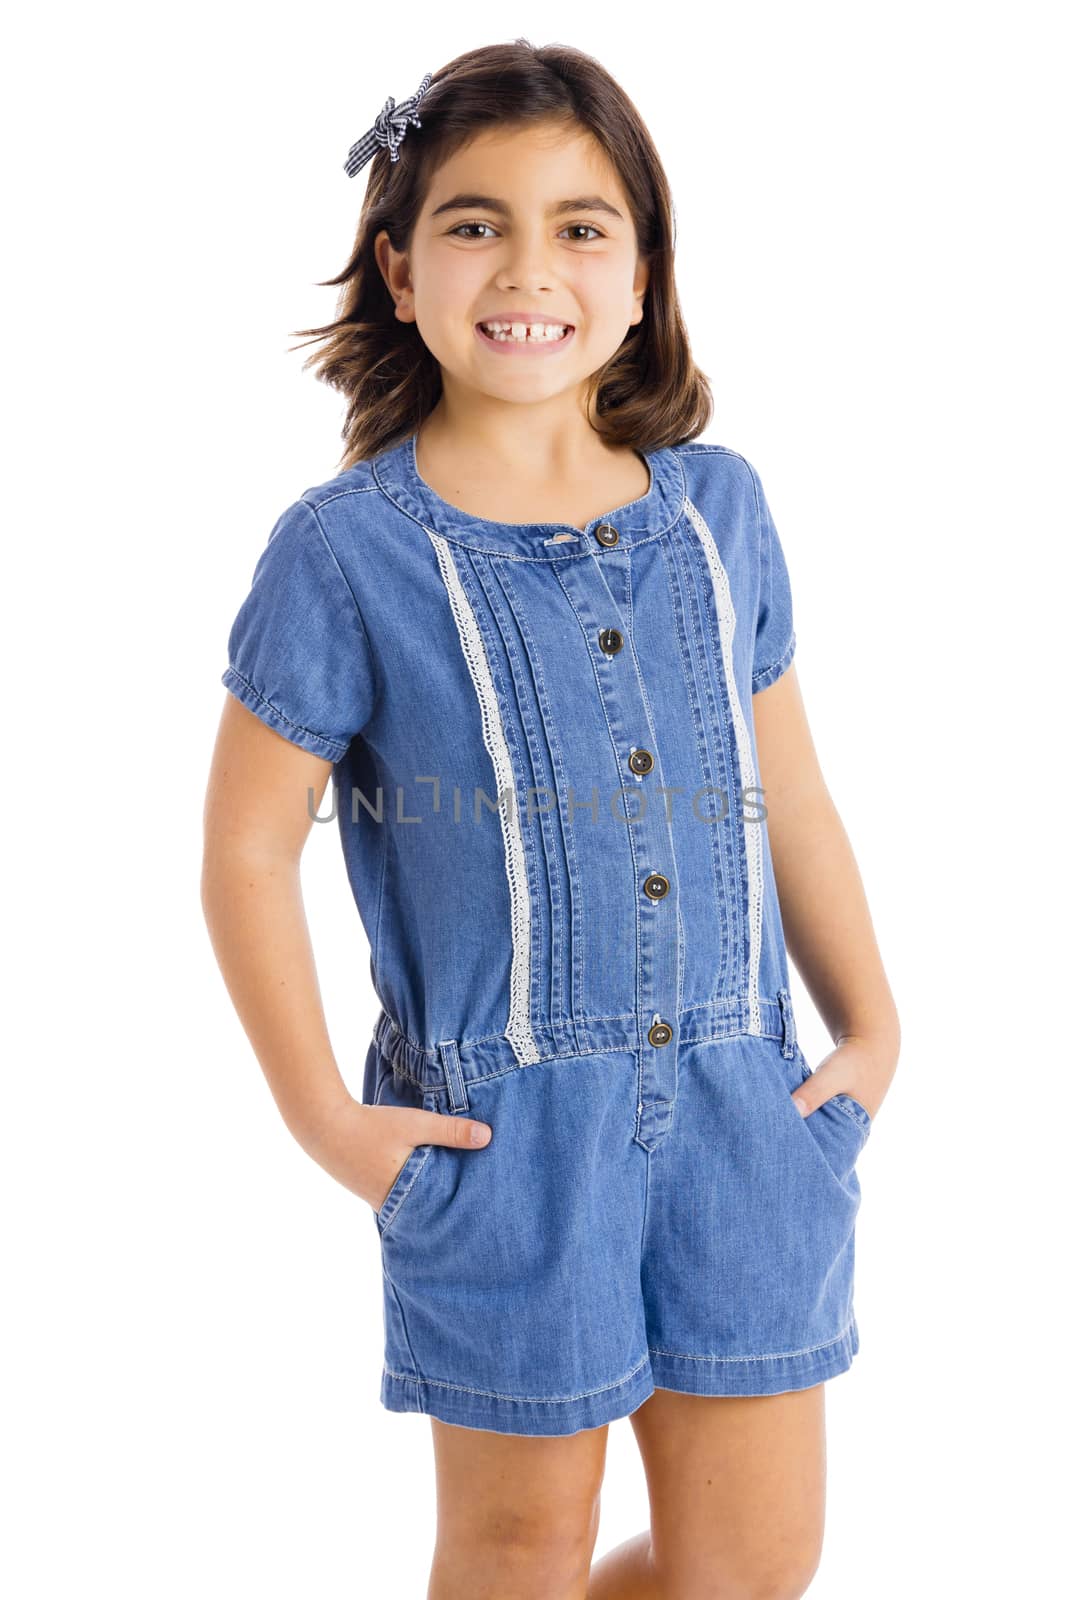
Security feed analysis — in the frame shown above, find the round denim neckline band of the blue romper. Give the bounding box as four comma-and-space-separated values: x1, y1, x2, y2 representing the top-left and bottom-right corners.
373, 429, 685, 560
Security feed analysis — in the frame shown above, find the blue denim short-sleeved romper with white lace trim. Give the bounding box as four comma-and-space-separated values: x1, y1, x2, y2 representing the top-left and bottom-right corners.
222, 435, 870, 1435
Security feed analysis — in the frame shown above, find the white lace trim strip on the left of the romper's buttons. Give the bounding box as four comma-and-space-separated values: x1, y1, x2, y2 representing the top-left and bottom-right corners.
426, 528, 541, 1066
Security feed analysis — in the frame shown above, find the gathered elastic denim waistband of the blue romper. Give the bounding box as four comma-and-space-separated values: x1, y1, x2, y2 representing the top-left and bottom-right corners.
374, 989, 797, 1109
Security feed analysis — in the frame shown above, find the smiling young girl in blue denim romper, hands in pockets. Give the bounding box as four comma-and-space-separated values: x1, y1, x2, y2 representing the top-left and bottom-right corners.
203, 40, 899, 1600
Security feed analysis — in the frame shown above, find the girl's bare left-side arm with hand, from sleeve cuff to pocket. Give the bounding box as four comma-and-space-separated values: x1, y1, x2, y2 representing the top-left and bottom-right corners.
200, 694, 492, 1206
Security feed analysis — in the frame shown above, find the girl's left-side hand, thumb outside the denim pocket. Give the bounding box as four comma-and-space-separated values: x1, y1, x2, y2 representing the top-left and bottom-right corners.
293, 1094, 493, 1211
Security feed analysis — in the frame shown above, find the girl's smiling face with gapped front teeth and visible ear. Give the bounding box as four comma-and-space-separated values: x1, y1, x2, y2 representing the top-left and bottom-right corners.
374, 123, 648, 419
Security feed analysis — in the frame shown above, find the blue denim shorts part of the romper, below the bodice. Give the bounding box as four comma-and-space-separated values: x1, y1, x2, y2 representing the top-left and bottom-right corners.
363, 992, 870, 1435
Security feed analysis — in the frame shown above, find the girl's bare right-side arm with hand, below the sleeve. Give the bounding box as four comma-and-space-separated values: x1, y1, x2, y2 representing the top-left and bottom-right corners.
752, 664, 901, 1117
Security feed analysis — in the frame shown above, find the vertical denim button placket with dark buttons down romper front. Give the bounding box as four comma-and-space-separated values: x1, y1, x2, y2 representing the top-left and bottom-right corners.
557, 537, 681, 1150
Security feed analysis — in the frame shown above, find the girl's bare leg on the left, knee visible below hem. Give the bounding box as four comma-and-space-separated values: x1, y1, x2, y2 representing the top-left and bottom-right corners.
427, 1418, 608, 1600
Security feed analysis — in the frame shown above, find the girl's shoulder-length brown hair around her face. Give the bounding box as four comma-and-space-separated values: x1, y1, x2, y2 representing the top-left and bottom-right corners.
293, 38, 713, 470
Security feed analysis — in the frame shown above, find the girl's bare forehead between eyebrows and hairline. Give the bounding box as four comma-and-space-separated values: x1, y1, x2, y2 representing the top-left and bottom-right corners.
424, 123, 630, 218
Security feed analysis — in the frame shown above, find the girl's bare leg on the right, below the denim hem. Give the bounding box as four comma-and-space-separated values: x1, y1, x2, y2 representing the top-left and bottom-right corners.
589, 1384, 825, 1600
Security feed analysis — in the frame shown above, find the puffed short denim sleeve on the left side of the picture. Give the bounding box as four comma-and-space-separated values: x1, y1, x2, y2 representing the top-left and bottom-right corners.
222, 501, 374, 762
